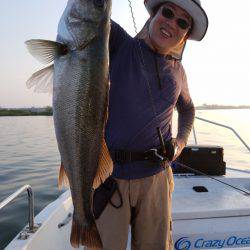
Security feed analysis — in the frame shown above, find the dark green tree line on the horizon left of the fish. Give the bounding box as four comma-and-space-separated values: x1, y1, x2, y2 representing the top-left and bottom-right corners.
0, 106, 53, 116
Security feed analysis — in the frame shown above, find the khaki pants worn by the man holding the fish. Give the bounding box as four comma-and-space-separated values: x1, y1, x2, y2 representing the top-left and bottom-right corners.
88, 167, 174, 250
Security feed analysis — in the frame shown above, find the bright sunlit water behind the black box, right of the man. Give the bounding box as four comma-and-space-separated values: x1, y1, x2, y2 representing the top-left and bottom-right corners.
186, 109, 250, 170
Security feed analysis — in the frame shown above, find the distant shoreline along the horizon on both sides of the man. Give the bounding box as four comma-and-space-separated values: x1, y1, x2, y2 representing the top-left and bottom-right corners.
0, 105, 250, 117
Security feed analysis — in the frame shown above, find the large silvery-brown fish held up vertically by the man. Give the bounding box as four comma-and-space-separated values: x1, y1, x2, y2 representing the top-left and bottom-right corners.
26, 0, 113, 247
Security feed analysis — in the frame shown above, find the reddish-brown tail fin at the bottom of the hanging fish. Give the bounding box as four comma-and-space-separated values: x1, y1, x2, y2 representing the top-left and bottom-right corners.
70, 217, 102, 249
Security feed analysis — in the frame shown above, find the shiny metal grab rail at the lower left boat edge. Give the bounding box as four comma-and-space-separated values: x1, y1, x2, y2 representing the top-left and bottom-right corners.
0, 185, 35, 232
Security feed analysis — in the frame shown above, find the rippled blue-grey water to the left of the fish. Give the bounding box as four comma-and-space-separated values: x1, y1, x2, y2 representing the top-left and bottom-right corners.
0, 117, 64, 249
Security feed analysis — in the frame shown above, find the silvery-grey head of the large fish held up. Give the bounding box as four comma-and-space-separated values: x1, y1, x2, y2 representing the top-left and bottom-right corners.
67, 0, 111, 48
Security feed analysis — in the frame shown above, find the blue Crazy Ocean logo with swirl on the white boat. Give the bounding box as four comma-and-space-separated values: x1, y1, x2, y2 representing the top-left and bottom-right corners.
174, 236, 250, 250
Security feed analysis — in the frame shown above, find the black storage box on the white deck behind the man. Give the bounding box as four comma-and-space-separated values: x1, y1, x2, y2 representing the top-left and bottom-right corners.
173, 145, 226, 175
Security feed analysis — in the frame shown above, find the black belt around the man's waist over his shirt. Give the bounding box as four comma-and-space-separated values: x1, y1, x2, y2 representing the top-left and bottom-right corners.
110, 148, 167, 164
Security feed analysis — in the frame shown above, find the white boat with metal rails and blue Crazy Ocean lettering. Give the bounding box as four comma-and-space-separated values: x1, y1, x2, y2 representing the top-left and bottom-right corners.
3, 117, 250, 250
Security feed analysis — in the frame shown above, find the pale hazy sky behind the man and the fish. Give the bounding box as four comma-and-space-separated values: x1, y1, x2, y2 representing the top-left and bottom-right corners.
0, 0, 250, 107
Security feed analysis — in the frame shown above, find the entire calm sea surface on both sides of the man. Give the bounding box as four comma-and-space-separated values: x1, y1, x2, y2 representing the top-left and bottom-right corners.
0, 109, 250, 249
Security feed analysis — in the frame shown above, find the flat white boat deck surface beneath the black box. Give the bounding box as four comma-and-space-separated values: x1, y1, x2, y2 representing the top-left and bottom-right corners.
172, 169, 250, 220
